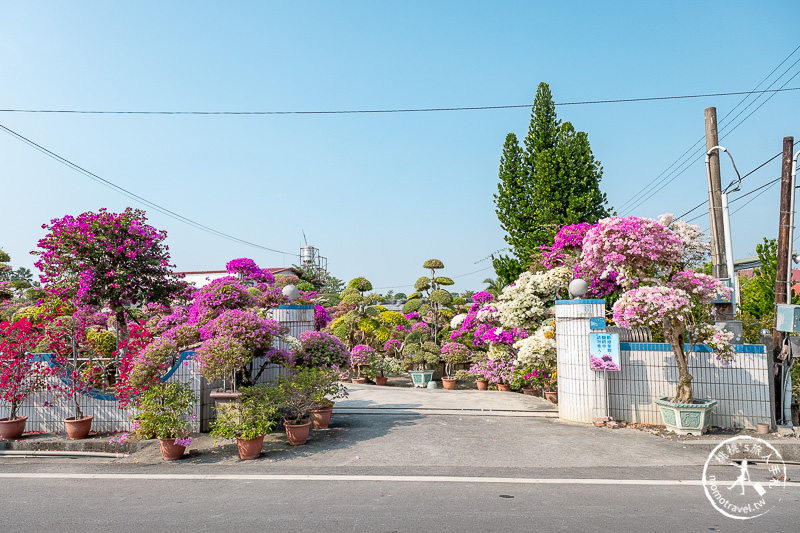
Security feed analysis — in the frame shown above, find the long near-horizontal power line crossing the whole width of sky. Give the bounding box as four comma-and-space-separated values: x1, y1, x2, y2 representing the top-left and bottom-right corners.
0, 87, 800, 115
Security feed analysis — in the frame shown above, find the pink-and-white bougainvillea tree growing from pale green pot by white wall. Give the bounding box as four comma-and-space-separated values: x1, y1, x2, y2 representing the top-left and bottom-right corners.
578, 215, 733, 404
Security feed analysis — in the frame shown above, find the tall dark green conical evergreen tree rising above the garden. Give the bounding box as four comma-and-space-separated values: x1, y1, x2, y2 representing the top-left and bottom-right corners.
492, 82, 609, 284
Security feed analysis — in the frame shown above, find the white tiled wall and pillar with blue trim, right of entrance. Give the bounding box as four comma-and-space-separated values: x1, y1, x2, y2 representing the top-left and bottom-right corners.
556, 300, 772, 429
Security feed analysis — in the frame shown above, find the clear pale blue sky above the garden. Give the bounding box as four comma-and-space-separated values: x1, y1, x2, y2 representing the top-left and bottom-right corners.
0, 1, 800, 292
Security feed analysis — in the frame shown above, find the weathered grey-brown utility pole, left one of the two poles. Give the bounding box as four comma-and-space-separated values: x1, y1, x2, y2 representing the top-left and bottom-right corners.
705, 107, 732, 279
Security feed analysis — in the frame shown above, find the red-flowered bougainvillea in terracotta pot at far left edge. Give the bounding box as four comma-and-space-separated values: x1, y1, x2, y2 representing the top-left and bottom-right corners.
0, 318, 53, 440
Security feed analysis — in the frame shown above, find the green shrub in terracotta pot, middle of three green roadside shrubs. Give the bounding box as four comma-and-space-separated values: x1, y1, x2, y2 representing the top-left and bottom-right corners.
211, 385, 278, 460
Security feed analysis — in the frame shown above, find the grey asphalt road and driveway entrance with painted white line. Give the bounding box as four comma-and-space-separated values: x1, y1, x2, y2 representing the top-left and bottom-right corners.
0, 413, 800, 532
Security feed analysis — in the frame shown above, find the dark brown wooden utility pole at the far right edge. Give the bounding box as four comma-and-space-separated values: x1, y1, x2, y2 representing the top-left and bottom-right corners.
772, 137, 794, 357
